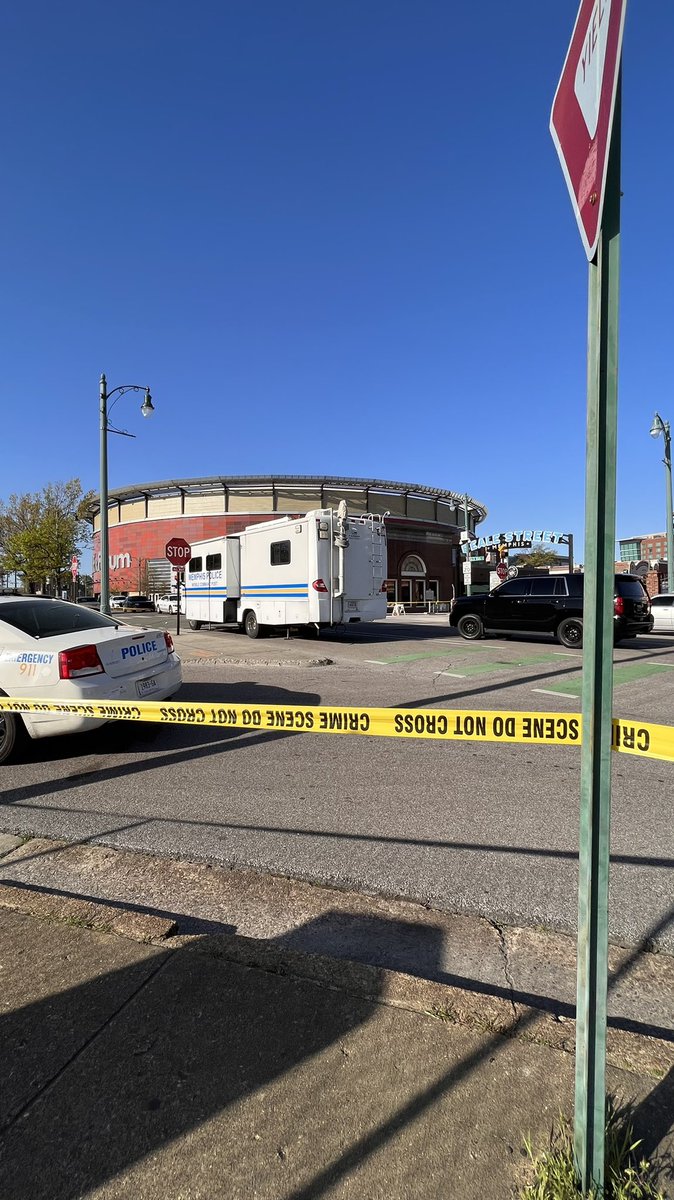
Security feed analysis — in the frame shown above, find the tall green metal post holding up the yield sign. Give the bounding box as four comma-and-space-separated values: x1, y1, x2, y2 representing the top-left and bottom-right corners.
574, 72, 621, 1192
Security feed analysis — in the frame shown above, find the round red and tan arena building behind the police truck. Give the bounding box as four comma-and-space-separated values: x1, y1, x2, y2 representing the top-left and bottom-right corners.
91, 475, 487, 610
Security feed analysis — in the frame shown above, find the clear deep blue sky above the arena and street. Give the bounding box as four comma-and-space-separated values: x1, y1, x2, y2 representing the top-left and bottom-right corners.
0, 0, 674, 556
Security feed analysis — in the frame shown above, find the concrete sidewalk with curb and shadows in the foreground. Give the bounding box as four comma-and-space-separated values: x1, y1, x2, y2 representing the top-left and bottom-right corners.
0, 859, 674, 1200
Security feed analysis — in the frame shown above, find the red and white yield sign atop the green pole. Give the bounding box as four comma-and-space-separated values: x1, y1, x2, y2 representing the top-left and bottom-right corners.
550, 0, 627, 262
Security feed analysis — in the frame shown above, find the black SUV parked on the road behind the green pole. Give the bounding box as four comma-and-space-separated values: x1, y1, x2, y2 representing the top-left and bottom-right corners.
450, 574, 652, 648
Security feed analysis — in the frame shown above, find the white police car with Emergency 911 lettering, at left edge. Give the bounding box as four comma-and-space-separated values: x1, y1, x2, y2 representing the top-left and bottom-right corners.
0, 596, 182, 763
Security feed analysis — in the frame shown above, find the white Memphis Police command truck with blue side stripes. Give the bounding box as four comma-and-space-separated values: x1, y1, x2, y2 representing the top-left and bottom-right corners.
185, 500, 386, 637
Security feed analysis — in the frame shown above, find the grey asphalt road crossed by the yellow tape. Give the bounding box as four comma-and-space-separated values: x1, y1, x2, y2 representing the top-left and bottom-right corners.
0, 617, 674, 952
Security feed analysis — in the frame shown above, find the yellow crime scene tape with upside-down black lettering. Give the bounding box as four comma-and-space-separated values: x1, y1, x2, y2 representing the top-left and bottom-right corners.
0, 696, 674, 762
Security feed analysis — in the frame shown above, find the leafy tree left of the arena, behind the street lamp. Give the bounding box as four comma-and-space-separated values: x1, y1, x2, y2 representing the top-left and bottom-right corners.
0, 479, 92, 593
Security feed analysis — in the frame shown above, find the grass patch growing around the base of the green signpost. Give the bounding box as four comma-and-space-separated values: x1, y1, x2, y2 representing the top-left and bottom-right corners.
518, 1098, 664, 1200
